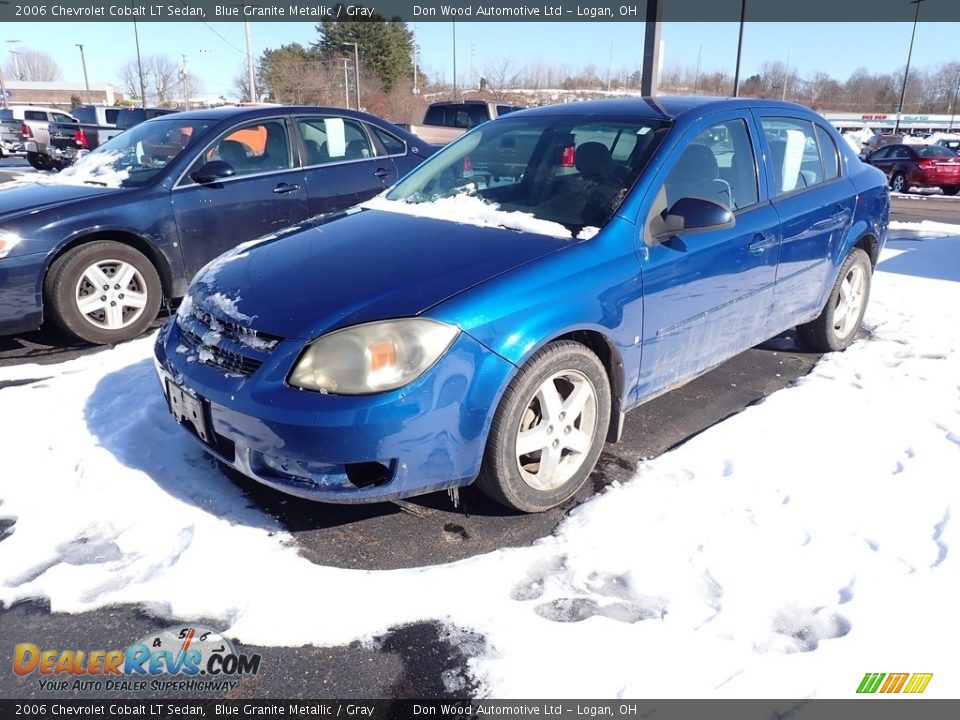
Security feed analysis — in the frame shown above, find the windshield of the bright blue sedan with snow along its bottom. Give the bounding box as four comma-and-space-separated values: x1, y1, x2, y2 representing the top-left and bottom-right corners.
380, 116, 668, 237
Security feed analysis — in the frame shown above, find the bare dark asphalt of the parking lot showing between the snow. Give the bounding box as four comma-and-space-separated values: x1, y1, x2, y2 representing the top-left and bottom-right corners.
0, 160, 960, 699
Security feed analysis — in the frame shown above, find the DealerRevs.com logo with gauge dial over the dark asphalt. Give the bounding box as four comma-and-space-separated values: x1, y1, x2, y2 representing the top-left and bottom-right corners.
13, 625, 261, 691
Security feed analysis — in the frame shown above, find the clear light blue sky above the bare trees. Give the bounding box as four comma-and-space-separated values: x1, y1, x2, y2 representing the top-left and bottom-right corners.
0, 22, 960, 100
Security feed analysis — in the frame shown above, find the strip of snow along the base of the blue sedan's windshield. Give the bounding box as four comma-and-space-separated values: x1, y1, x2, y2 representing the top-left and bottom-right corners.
360, 193, 573, 239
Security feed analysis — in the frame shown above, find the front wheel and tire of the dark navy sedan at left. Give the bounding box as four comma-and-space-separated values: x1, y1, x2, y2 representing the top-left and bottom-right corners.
44, 241, 163, 345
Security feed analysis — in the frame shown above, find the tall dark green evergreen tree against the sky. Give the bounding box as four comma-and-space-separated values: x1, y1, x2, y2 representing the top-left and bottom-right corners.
314, 5, 413, 93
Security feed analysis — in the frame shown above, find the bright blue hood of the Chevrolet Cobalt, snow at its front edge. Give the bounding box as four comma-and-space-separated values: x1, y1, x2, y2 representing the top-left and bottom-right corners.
190, 209, 574, 339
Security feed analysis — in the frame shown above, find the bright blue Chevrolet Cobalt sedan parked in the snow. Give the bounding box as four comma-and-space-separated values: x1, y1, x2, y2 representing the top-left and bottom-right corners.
156, 98, 889, 512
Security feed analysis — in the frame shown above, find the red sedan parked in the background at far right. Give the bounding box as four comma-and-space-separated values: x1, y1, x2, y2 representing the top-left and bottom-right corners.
864, 145, 960, 195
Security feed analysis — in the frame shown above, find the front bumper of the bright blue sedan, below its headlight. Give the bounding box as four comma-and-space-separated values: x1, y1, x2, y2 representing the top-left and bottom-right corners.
155, 318, 515, 503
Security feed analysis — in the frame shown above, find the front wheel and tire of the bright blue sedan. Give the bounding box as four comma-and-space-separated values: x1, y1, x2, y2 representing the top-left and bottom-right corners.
477, 340, 610, 512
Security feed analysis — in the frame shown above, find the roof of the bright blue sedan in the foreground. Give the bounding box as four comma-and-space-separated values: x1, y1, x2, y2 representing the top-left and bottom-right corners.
510, 95, 811, 120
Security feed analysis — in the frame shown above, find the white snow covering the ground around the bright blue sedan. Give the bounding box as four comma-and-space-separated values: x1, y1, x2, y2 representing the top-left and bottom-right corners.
0, 226, 960, 698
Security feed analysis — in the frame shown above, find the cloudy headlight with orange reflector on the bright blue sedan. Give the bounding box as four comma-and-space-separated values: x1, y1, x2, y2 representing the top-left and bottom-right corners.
287, 318, 460, 395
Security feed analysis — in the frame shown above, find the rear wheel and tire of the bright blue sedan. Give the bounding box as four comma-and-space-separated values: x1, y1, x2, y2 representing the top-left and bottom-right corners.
797, 248, 873, 352
